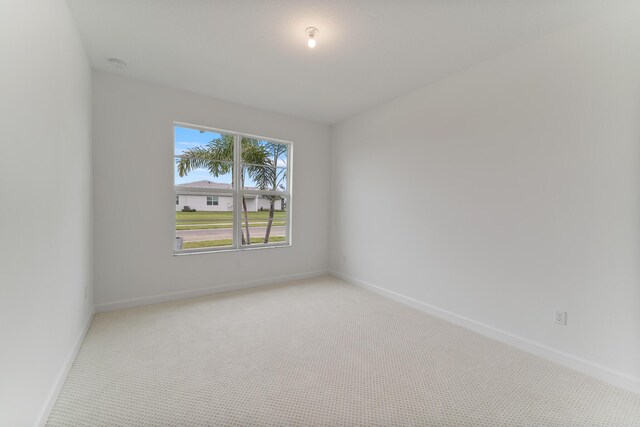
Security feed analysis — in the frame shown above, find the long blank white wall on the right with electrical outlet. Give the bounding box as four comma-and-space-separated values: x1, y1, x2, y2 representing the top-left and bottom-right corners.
331, 2, 640, 391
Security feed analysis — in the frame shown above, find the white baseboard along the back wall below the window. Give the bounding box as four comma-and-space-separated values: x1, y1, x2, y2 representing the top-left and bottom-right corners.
96, 270, 329, 313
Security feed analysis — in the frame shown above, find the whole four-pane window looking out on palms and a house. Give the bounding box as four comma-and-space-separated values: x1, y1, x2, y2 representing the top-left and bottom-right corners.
173, 123, 292, 254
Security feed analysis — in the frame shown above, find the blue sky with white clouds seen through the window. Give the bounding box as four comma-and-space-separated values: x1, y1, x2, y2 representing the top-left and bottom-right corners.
174, 126, 287, 187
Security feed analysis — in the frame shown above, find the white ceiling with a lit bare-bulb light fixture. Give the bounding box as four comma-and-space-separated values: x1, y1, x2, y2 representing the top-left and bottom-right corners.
68, 0, 615, 124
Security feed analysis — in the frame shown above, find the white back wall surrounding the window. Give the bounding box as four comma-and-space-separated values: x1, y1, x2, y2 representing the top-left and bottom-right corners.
93, 72, 330, 309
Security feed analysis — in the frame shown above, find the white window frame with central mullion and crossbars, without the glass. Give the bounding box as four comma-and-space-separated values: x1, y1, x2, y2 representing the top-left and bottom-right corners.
171, 121, 293, 255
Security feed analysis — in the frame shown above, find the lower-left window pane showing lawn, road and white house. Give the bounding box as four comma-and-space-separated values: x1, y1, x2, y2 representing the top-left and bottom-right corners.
176, 193, 233, 250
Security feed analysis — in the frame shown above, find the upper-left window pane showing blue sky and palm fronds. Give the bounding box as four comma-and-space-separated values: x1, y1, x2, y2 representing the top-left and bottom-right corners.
174, 126, 234, 187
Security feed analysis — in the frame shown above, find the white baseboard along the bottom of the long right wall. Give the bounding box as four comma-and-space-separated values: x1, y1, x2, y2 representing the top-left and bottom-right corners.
329, 271, 640, 394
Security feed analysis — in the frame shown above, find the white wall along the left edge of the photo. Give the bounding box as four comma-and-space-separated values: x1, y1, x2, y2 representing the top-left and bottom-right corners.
0, 0, 93, 426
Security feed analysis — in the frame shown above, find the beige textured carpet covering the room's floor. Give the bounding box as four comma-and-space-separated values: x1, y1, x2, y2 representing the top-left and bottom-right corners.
48, 277, 640, 426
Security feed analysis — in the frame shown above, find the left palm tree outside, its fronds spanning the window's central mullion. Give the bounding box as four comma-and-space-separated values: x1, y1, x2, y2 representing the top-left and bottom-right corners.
176, 135, 273, 245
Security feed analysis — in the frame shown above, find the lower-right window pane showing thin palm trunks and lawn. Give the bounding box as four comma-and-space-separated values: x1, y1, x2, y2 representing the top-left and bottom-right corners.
242, 195, 287, 245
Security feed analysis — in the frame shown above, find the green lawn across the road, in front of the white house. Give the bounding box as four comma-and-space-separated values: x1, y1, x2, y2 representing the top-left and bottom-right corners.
176, 211, 287, 230
